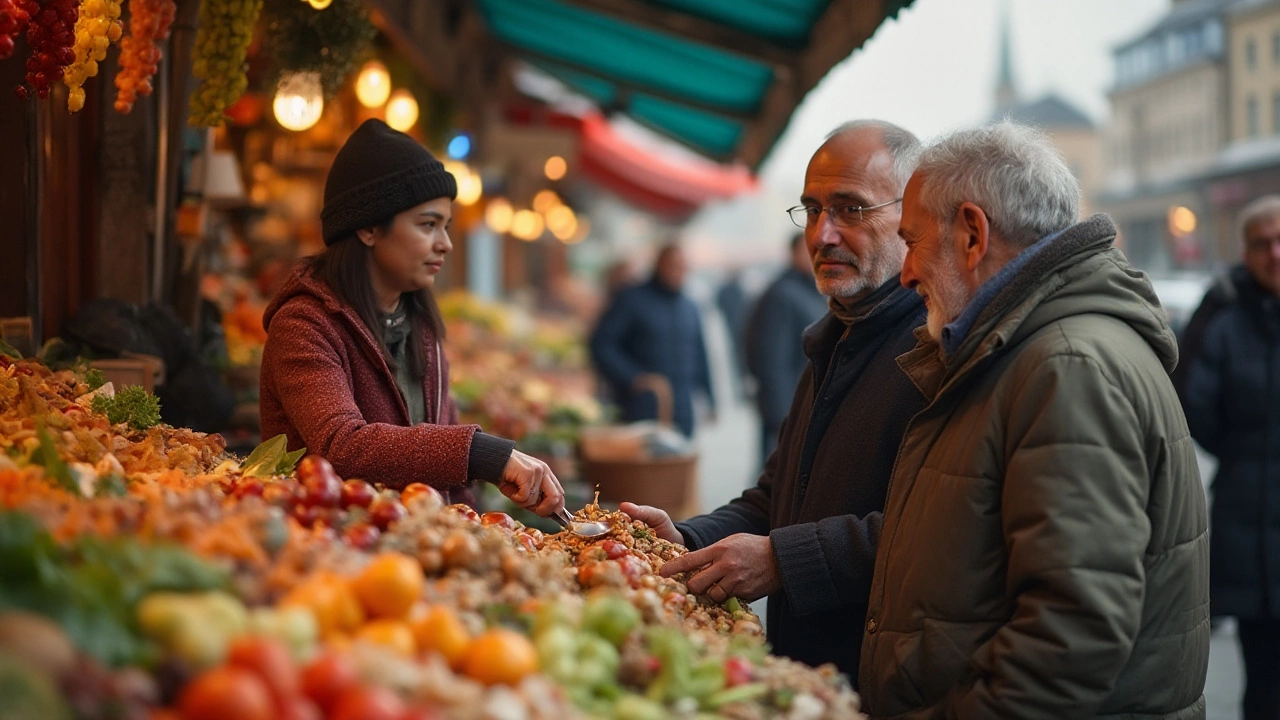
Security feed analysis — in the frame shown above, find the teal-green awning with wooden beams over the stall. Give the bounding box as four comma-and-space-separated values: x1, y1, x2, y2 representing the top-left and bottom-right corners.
476, 0, 910, 168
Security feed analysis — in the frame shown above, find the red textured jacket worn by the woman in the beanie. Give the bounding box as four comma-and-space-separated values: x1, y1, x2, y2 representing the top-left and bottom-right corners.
260, 266, 479, 502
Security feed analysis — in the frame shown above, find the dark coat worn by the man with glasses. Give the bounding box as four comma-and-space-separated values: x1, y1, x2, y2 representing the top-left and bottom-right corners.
677, 277, 924, 680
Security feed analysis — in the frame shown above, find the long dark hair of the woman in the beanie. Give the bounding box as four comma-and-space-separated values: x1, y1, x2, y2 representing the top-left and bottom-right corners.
308, 217, 444, 378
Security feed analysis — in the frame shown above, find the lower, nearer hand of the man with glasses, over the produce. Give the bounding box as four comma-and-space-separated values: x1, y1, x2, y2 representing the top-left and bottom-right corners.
659, 533, 782, 602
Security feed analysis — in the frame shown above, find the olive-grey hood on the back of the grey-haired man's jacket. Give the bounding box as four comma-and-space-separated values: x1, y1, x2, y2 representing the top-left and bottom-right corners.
955, 214, 1178, 372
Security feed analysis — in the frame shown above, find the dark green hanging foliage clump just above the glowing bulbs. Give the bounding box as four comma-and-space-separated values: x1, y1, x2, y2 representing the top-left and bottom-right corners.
262, 0, 378, 99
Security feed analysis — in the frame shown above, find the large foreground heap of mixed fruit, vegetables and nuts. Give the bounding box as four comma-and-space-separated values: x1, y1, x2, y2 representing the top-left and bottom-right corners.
0, 356, 860, 720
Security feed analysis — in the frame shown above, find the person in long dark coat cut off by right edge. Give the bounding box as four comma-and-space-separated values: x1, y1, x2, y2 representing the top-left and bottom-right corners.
1181, 196, 1280, 720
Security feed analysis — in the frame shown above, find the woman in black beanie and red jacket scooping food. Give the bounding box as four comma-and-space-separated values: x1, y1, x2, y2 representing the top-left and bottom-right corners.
261, 119, 564, 515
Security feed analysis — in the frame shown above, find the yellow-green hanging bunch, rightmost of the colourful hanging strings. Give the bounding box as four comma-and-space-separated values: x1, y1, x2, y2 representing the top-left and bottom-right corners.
187, 0, 262, 127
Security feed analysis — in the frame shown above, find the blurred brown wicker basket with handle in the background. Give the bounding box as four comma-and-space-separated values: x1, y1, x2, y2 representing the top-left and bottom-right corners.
579, 375, 698, 520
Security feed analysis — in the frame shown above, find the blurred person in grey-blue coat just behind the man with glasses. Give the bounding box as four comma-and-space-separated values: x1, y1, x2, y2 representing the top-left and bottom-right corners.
745, 233, 827, 466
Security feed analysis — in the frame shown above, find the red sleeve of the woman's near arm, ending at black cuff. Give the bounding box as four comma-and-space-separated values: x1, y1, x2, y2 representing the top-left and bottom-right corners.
262, 302, 479, 488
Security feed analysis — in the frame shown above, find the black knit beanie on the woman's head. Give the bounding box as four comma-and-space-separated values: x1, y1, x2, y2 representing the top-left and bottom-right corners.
320, 118, 458, 245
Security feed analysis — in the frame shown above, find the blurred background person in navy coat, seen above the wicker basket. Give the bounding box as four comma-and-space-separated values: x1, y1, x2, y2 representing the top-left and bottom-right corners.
591, 245, 714, 437
